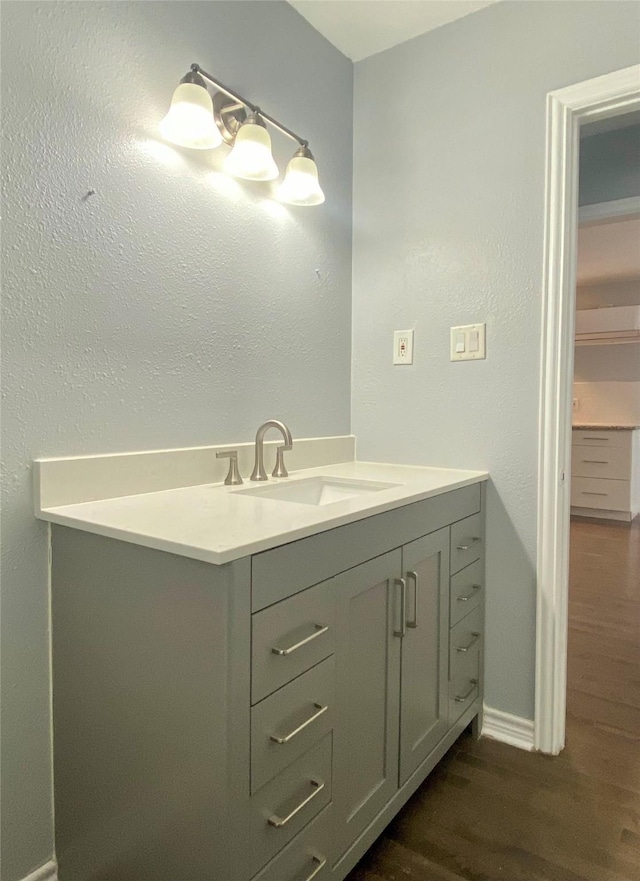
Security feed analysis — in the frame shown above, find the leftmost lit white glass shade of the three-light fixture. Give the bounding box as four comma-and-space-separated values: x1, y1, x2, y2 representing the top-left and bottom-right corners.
160, 83, 222, 150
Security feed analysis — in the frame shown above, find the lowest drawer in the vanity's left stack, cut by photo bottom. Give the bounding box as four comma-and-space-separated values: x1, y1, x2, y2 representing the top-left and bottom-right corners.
253, 806, 332, 881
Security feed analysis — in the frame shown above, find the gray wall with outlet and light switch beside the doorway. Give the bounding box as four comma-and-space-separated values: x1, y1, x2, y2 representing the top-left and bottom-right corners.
352, 0, 640, 718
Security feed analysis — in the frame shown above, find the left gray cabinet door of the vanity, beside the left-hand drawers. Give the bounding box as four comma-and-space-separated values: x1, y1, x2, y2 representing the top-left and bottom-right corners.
333, 550, 402, 857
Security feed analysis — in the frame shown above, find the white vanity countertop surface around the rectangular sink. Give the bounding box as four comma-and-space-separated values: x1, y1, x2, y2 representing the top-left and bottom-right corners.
38, 462, 488, 564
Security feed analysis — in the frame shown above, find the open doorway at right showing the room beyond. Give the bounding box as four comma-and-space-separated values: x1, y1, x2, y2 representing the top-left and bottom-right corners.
566, 113, 640, 752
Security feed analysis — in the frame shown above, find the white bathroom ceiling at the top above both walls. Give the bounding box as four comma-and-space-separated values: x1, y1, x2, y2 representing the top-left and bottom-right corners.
289, 0, 499, 61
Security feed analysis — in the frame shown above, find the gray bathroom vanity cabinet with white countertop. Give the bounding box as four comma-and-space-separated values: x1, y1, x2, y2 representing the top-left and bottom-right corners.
39, 450, 487, 881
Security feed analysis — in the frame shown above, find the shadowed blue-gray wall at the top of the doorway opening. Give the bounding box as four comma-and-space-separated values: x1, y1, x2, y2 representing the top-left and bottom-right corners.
580, 121, 640, 205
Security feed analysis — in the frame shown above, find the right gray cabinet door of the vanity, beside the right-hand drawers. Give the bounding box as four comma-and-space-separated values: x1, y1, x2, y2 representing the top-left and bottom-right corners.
400, 528, 449, 785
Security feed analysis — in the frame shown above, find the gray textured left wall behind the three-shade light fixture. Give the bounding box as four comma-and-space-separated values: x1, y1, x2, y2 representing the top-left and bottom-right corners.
2, 2, 353, 881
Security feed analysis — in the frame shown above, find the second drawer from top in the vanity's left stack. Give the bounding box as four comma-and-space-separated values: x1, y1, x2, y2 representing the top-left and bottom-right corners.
251, 657, 335, 792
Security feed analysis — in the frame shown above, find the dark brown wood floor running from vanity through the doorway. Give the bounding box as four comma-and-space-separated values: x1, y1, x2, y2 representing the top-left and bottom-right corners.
348, 518, 640, 881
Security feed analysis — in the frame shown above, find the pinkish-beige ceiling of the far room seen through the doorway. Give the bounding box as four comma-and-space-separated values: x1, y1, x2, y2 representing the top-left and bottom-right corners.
578, 219, 640, 285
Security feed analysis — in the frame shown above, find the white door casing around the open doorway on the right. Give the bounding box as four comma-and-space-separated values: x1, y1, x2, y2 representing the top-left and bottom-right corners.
534, 65, 640, 755
